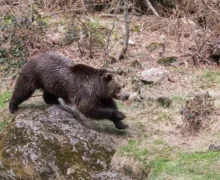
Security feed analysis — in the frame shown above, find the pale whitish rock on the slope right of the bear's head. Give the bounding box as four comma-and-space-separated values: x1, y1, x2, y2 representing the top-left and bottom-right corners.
140, 68, 169, 84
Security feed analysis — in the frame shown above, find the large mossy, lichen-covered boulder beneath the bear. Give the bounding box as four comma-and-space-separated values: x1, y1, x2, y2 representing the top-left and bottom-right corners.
0, 106, 122, 180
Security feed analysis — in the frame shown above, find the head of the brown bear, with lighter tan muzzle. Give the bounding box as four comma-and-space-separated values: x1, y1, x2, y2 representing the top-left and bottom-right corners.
102, 72, 129, 101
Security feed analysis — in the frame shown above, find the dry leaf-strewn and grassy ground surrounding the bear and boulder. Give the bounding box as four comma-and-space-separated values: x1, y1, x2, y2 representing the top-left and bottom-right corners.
0, 8, 220, 180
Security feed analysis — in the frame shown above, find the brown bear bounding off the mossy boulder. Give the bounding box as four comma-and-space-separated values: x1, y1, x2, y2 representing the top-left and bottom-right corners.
9, 53, 128, 129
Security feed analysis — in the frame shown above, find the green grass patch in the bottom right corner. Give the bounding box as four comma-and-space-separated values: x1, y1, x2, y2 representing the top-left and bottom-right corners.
148, 151, 220, 180
